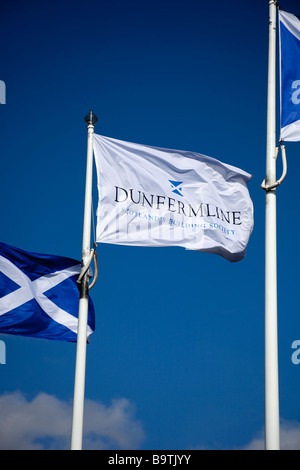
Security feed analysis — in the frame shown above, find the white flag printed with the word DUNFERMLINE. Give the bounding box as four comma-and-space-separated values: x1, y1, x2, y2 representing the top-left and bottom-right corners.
94, 135, 253, 261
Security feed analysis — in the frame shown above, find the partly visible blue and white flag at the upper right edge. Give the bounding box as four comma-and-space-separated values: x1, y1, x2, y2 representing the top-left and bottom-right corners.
279, 11, 300, 142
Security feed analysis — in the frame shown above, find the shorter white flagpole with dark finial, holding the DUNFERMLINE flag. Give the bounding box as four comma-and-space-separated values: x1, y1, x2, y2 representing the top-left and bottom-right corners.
71, 111, 98, 450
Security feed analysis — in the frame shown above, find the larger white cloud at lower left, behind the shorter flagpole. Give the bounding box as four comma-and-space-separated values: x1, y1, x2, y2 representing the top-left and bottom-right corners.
0, 392, 144, 450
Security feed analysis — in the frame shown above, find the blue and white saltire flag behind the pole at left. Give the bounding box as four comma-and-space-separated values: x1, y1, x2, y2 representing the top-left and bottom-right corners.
0, 242, 95, 342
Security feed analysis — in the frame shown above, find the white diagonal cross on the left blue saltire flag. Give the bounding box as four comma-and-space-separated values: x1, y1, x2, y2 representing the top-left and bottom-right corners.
0, 255, 92, 335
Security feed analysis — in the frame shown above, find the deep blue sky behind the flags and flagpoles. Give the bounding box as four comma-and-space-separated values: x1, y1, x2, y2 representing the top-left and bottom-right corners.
0, 0, 300, 450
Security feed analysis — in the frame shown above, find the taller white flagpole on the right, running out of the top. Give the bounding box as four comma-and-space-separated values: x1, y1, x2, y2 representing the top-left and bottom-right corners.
265, 0, 280, 450
